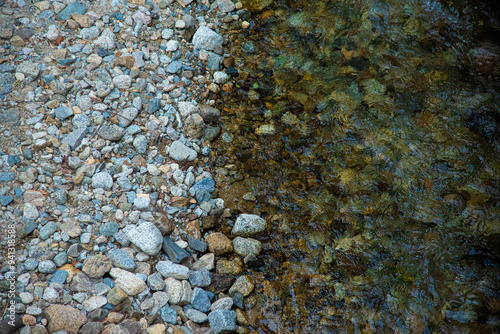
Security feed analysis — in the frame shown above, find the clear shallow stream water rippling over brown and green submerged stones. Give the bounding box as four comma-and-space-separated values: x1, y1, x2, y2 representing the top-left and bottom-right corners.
218, 0, 500, 333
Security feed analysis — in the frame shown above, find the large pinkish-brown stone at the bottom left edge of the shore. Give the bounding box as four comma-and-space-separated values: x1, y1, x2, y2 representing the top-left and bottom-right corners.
45, 304, 87, 334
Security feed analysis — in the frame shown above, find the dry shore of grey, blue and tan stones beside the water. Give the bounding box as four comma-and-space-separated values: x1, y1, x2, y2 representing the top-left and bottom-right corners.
0, 0, 267, 334
